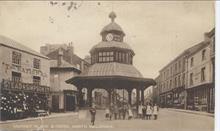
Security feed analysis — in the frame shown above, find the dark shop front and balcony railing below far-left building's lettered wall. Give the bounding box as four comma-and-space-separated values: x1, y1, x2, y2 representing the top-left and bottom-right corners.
1, 80, 50, 120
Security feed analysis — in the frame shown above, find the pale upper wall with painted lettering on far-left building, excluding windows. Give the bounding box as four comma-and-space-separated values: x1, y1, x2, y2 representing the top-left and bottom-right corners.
0, 46, 50, 87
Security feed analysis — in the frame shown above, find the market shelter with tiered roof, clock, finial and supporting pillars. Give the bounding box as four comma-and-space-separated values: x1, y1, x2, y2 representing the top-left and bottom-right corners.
66, 12, 156, 110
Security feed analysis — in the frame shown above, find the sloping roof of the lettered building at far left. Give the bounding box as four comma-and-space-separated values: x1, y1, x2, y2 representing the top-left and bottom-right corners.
0, 35, 49, 59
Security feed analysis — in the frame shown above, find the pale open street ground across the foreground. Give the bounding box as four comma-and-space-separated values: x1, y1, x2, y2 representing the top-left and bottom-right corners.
0, 109, 214, 131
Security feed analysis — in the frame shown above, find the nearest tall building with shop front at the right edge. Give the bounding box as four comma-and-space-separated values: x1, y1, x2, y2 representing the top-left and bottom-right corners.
186, 29, 215, 112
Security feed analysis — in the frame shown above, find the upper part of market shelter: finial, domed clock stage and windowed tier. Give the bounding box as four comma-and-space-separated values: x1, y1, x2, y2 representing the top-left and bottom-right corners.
90, 12, 135, 65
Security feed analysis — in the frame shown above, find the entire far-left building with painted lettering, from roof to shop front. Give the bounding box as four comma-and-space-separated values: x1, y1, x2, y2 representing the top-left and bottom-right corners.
0, 36, 50, 119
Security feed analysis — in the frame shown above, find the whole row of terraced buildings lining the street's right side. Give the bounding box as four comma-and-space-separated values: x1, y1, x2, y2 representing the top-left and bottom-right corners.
153, 29, 215, 112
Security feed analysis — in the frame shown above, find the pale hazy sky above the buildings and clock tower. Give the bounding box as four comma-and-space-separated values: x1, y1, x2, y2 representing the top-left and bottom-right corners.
0, 1, 215, 78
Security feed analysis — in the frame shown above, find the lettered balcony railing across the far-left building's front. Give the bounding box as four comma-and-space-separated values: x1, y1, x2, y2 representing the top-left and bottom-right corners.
1, 79, 50, 93
